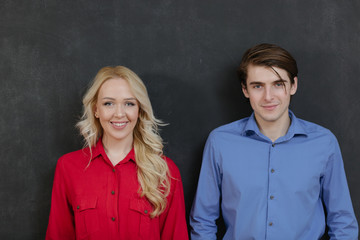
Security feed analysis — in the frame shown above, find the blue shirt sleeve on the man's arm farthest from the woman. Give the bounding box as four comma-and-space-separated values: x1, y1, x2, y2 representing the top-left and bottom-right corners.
322, 136, 358, 240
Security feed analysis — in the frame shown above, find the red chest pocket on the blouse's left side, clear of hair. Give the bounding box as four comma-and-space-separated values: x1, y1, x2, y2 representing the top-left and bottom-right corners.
73, 196, 100, 239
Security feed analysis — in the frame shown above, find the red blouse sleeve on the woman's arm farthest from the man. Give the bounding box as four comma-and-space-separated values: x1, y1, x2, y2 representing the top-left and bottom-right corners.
45, 158, 75, 240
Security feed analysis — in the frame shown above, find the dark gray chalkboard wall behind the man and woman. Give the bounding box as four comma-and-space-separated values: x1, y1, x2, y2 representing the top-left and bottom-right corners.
0, 0, 360, 239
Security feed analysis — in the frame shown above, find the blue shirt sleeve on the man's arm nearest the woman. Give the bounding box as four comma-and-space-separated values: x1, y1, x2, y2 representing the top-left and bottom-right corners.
190, 135, 221, 240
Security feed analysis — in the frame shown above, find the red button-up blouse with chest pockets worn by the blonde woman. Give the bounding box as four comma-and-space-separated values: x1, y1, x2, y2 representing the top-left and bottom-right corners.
46, 140, 188, 240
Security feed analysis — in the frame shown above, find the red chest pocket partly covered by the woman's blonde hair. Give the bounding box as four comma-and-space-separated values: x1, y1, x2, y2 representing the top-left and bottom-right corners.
129, 197, 154, 239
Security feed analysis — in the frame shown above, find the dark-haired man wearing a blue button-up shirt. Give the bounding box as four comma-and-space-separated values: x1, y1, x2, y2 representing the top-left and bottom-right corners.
190, 44, 358, 240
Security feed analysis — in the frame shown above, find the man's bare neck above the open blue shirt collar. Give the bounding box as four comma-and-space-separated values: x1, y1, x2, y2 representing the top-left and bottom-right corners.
255, 114, 291, 142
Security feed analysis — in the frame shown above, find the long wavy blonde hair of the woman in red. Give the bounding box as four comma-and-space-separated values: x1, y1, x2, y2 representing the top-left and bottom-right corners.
76, 66, 170, 218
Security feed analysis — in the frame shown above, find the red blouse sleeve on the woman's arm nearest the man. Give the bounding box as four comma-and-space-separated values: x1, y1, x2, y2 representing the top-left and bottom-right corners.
160, 159, 189, 240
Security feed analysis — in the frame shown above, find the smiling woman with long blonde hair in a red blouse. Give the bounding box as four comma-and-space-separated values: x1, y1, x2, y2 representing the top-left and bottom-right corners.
46, 66, 188, 240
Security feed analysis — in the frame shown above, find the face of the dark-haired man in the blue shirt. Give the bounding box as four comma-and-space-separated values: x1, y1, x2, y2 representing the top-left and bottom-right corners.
242, 65, 297, 126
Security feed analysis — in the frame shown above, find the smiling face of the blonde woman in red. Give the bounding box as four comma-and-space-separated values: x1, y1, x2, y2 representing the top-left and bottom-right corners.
95, 78, 139, 144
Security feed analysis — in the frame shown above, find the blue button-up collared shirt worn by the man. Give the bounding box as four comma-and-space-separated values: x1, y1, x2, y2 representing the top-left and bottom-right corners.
190, 111, 358, 240
